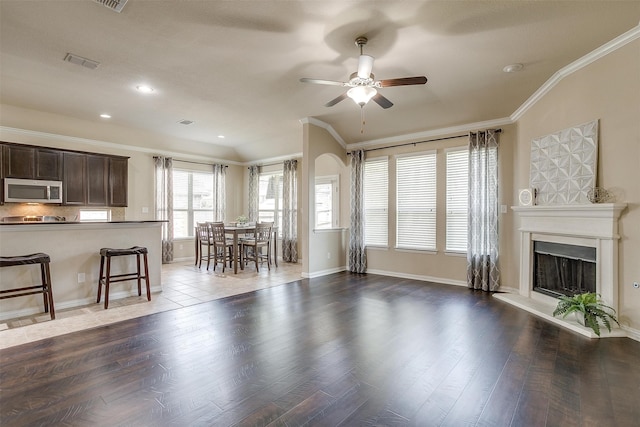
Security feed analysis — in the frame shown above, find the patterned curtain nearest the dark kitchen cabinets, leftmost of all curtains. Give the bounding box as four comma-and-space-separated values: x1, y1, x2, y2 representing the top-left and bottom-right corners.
153, 157, 173, 264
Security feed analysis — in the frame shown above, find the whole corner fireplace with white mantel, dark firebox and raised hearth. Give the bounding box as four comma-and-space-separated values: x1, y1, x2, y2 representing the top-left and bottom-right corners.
495, 203, 627, 337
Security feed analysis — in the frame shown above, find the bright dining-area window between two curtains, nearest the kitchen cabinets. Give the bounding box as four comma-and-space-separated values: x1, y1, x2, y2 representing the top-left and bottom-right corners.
173, 169, 214, 239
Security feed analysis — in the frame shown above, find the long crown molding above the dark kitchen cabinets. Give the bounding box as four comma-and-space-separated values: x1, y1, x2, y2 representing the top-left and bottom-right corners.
0, 126, 248, 166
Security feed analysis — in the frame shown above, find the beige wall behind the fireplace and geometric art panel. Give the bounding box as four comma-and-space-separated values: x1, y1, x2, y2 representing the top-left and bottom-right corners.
507, 40, 640, 331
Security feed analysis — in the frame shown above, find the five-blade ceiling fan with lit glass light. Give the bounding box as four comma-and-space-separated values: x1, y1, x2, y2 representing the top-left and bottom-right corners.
300, 36, 427, 109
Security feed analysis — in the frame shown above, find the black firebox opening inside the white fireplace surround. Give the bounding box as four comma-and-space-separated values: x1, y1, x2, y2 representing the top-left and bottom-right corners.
533, 241, 596, 298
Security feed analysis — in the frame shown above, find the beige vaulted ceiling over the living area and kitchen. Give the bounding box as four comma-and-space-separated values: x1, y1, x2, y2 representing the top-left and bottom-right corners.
0, 0, 640, 162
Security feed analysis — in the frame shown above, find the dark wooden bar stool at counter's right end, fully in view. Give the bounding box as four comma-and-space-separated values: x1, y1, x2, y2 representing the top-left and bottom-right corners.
96, 246, 151, 309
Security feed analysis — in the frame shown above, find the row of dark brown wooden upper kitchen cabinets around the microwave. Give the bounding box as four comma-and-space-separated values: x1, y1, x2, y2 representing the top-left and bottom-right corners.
0, 143, 129, 207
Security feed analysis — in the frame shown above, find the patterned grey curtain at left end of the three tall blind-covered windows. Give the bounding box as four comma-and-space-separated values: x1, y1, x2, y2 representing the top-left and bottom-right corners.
349, 150, 367, 273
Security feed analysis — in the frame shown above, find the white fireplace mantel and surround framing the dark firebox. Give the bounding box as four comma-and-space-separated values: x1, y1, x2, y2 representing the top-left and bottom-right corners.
498, 203, 627, 336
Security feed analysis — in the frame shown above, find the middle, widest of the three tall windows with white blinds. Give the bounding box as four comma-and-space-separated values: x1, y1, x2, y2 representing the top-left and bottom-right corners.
396, 152, 436, 250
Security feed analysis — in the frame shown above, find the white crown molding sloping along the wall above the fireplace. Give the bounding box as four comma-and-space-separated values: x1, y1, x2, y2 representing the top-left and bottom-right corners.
511, 25, 640, 122
